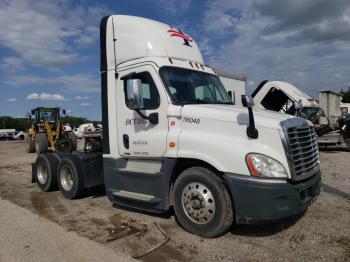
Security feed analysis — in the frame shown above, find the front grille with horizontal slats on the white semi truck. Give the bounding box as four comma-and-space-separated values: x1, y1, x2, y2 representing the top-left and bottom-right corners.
282, 118, 320, 180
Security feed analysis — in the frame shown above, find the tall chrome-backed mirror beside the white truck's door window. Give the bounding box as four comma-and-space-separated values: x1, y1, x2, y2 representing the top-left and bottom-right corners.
126, 79, 143, 110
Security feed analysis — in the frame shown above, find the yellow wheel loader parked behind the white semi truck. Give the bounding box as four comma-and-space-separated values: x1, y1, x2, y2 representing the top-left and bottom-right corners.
25, 107, 77, 154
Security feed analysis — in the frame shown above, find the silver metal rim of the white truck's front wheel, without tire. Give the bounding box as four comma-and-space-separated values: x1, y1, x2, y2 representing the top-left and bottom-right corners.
181, 182, 215, 224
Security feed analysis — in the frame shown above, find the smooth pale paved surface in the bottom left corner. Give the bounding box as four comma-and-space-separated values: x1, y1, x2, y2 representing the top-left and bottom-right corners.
0, 196, 132, 262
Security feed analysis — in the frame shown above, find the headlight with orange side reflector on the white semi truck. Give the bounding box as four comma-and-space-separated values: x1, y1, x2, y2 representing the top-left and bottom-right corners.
246, 153, 288, 178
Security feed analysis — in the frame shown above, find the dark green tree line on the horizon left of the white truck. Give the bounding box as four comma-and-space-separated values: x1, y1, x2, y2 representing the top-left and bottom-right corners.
0, 116, 101, 131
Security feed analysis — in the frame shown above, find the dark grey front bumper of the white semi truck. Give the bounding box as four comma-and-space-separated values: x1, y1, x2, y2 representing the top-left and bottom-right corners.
224, 172, 321, 224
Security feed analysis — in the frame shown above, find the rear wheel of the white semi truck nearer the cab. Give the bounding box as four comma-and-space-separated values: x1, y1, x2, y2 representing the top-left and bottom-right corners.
57, 156, 86, 199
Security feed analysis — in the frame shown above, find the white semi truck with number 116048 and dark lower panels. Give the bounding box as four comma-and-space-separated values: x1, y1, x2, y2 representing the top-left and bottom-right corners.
32, 15, 320, 237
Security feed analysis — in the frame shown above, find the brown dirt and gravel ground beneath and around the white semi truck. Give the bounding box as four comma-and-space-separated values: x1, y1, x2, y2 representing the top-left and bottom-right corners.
0, 142, 350, 261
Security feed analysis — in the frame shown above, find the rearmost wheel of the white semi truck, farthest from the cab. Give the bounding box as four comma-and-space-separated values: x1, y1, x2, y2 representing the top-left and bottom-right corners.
34, 153, 58, 192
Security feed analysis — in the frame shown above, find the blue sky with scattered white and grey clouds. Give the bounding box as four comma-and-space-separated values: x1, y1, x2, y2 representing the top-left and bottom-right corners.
0, 0, 350, 119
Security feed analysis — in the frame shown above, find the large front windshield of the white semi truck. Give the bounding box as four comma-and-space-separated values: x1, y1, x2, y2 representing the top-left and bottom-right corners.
160, 67, 232, 105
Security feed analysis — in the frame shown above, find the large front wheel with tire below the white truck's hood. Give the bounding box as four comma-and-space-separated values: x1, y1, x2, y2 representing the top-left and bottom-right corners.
174, 167, 233, 237
